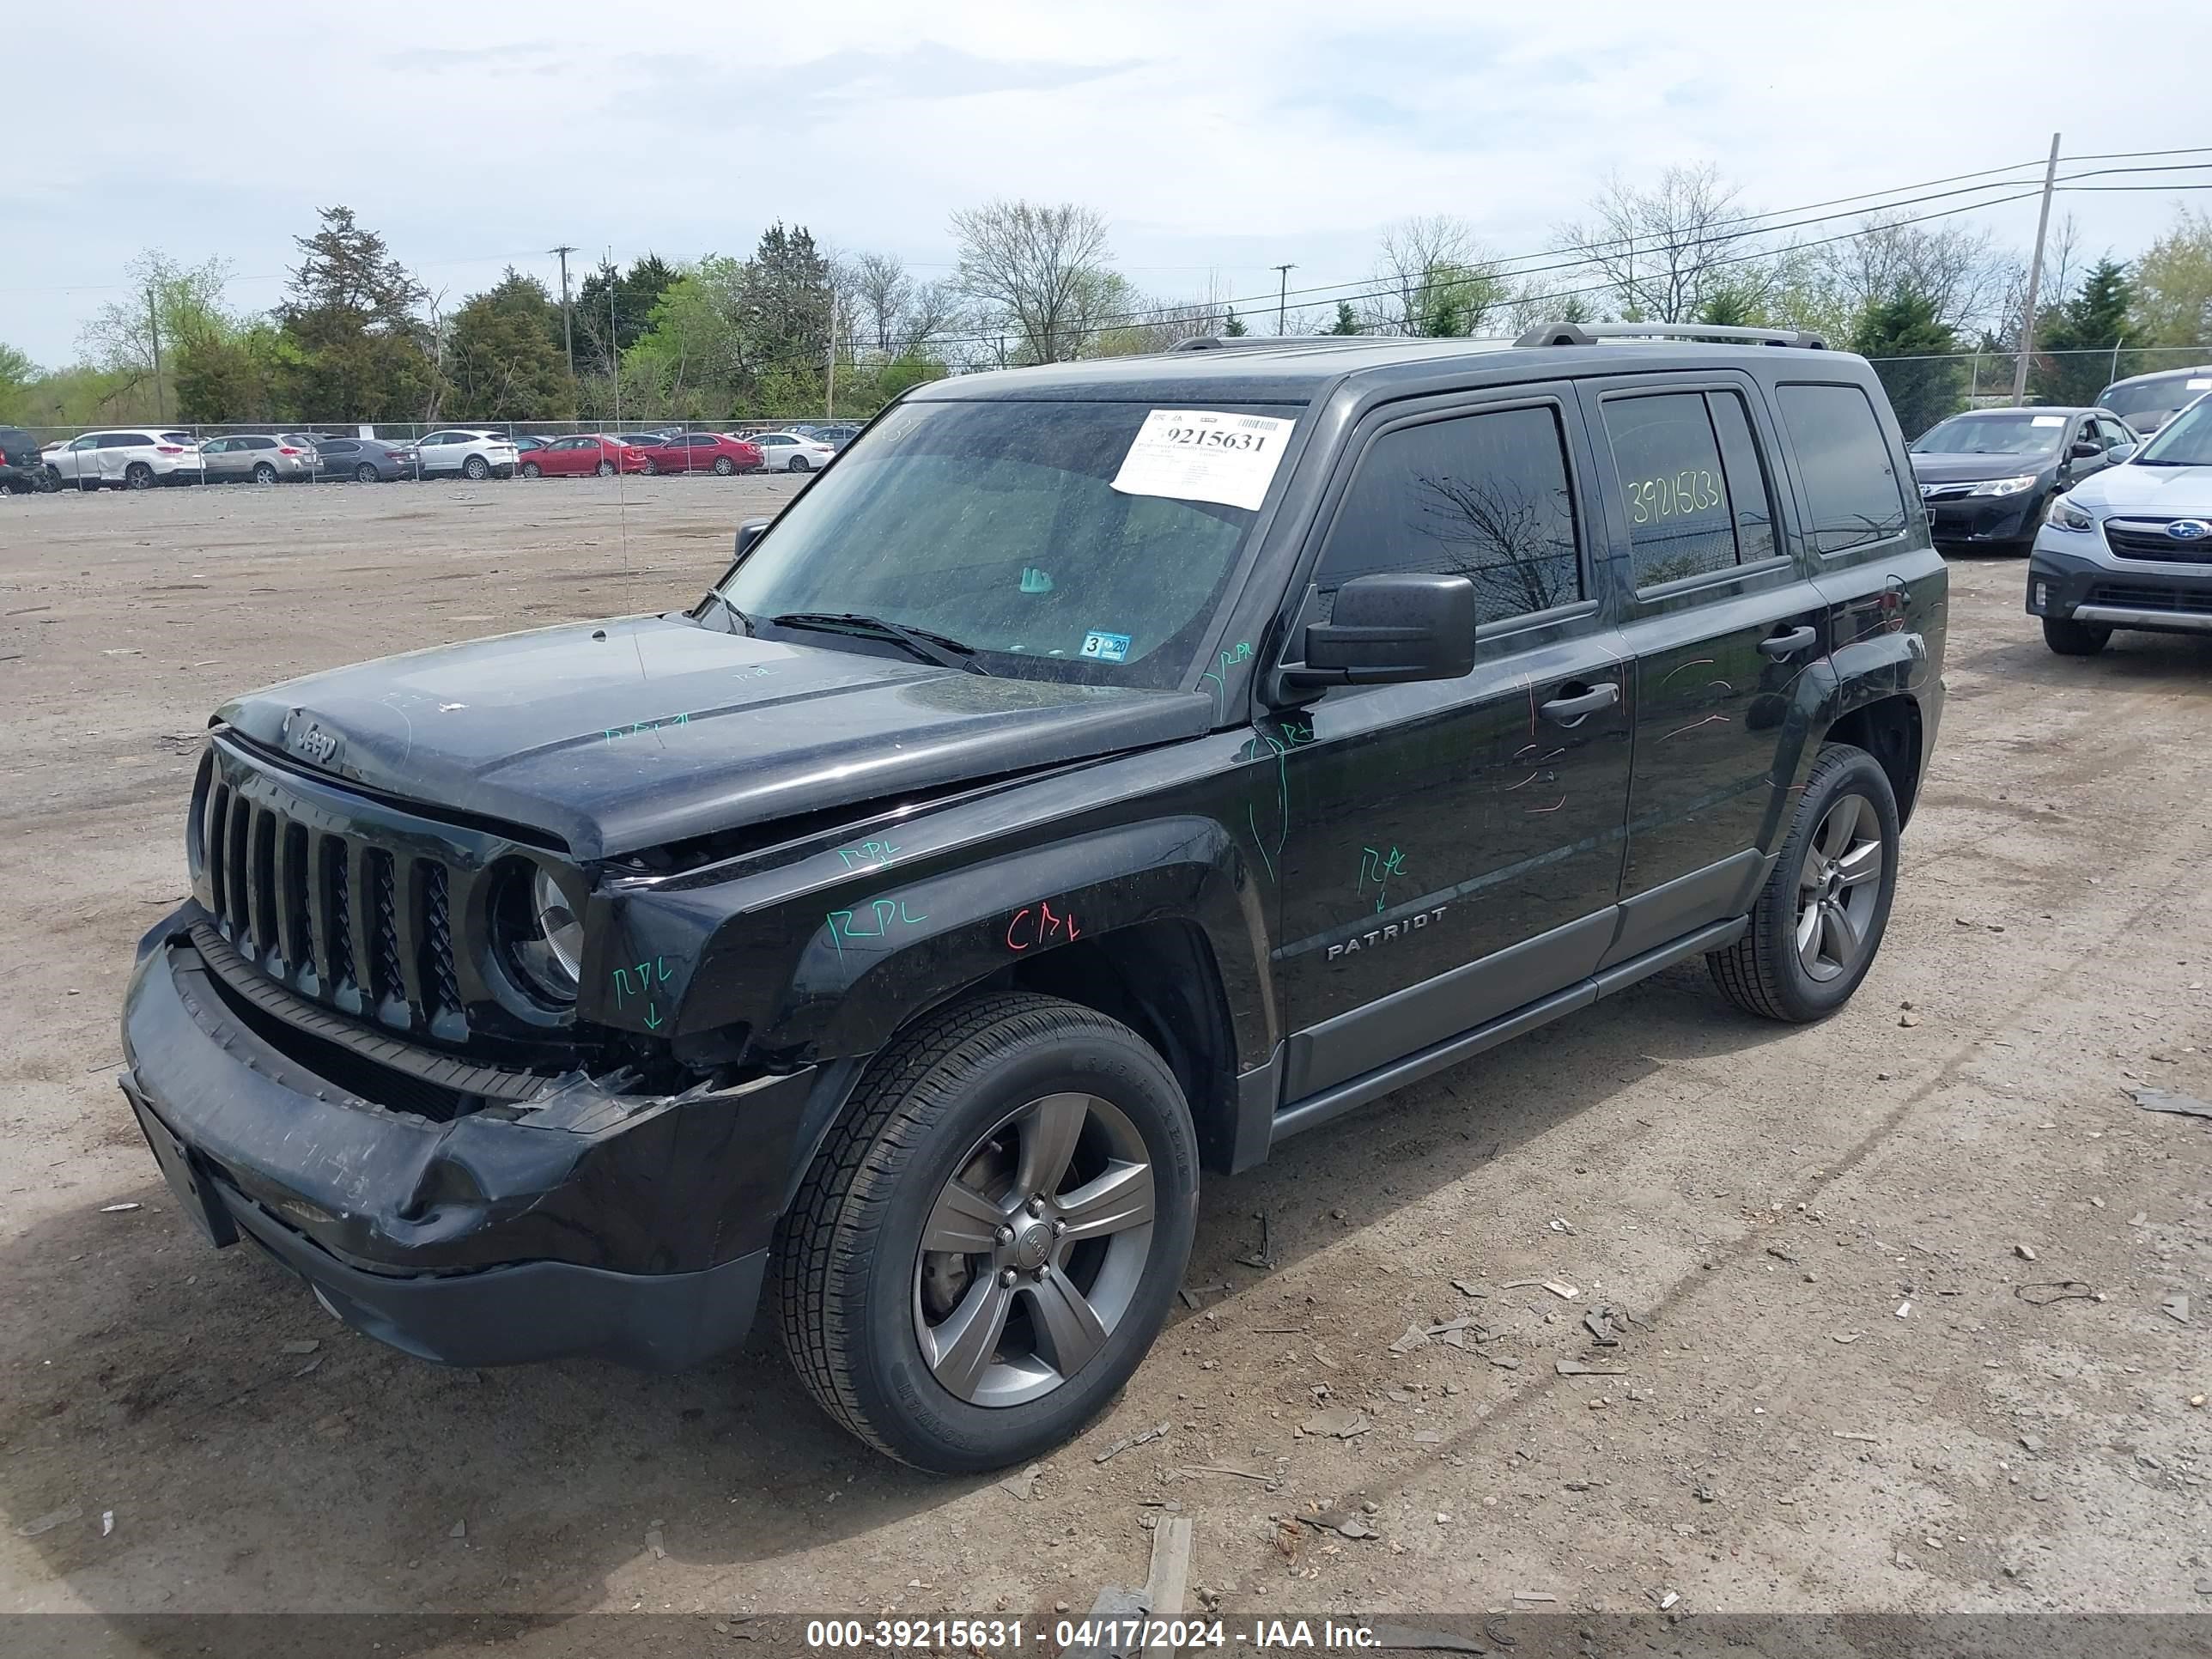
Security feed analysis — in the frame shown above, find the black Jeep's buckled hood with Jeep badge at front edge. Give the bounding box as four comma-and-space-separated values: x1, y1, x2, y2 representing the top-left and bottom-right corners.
216, 617, 1212, 858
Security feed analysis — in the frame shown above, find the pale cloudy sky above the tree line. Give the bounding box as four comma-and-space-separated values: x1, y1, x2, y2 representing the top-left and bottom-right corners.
0, 0, 2212, 365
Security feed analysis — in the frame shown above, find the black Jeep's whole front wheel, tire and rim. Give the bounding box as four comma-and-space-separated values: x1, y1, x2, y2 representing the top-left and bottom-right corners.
775, 995, 1199, 1474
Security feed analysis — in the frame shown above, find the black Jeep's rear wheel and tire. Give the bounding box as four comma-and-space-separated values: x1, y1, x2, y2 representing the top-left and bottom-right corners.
1705, 744, 1898, 1024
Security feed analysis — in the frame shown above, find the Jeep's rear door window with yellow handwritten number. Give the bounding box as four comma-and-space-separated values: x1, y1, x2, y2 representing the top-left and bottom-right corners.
1601, 392, 1774, 588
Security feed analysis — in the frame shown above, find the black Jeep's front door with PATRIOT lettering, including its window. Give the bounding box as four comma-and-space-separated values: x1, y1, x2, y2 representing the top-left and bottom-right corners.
1252, 387, 1635, 1102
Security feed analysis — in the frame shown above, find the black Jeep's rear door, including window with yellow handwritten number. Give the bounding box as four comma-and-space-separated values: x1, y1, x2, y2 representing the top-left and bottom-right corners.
1582, 369, 1829, 963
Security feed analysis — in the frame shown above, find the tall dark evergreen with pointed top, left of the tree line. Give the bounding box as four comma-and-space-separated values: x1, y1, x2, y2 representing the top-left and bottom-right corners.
276, 208, 435, 420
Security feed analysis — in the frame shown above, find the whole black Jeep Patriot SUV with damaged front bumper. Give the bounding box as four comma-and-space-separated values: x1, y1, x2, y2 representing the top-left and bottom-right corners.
124, 325, 1947, 1471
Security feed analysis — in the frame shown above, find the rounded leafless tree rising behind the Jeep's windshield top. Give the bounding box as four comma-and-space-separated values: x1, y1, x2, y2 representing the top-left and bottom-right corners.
953, 201, 1126, 362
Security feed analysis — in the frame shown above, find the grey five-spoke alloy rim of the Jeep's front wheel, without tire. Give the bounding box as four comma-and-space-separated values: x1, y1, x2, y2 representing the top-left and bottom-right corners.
914, 1095, 1152, 1407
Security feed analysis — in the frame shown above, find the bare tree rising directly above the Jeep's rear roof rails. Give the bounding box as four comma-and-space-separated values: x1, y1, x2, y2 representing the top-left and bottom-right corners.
1558, 161, 1760, 323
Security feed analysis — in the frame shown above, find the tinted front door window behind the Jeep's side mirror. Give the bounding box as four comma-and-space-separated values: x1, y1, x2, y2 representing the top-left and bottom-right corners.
1314, 407, 1582, 622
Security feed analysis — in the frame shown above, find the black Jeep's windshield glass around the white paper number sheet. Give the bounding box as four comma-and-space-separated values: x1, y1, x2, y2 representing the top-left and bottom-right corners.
721, 400, 1297, 688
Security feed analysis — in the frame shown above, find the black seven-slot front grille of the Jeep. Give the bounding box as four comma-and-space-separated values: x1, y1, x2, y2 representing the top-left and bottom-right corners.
199, 765, 467, 1040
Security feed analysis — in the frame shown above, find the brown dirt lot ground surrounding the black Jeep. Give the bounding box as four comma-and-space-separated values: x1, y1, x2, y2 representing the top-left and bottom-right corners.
0, 477, 2212, 1650
